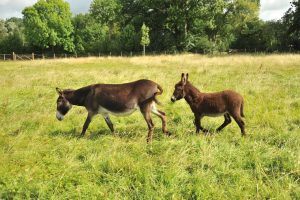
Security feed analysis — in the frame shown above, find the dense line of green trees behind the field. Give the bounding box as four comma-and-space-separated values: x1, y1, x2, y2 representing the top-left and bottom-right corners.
0, 0, 300, 54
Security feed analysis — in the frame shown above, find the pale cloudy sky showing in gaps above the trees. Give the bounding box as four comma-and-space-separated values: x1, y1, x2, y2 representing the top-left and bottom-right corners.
0, 0, 291, 20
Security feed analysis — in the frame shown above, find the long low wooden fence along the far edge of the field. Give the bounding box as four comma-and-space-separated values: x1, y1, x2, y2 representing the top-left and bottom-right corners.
0, 49, 300, 61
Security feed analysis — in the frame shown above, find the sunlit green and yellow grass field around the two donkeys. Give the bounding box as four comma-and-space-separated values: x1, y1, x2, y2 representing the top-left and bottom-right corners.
0, 55, 300, 200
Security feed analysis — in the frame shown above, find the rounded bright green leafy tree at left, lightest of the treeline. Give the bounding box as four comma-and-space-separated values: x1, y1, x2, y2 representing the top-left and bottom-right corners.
22, 0, 75, 52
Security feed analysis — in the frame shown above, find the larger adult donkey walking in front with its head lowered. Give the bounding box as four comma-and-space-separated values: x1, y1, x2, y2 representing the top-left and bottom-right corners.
56, 80, 169, 142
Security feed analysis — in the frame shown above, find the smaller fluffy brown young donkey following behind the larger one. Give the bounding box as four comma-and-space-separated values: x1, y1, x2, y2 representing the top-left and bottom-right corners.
171, 73, 246, 136
